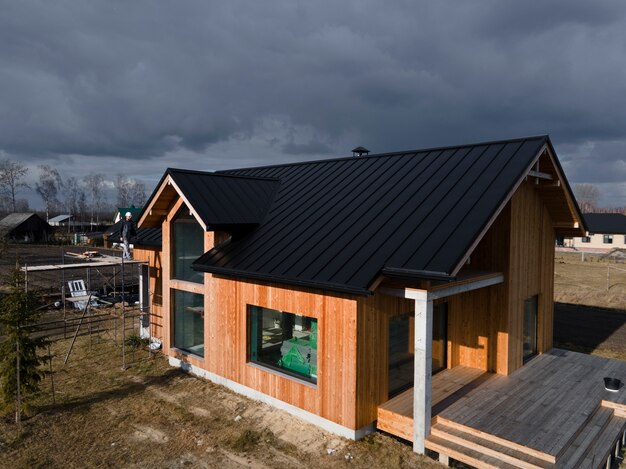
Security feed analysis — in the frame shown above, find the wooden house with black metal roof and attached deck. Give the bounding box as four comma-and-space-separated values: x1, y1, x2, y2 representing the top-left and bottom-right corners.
135, 136, 626, 467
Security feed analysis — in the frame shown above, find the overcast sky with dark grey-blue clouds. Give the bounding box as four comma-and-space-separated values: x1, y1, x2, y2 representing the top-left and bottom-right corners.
0, 0, 626, 206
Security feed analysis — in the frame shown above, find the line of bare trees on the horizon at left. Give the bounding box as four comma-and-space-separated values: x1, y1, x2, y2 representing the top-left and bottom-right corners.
0, 158, 146, 224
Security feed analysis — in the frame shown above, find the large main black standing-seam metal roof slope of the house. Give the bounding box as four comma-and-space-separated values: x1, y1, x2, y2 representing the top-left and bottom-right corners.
189, 136, 551, 294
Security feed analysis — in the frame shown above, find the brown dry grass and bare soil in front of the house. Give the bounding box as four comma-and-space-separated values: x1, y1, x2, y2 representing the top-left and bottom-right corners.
0, 336, 441, 469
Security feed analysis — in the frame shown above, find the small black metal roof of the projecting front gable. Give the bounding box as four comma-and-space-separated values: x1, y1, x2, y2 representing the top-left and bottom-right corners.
166, 168, 279, 229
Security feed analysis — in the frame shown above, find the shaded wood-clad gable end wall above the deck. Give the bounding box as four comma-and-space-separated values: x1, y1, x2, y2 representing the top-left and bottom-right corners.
448, 177, 554, 375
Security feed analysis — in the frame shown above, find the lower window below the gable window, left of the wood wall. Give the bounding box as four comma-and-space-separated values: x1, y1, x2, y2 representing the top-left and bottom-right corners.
172, 290, 204, 357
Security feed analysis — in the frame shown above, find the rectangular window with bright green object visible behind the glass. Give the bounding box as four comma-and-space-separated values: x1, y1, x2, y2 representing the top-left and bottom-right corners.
248, 306, 317, 383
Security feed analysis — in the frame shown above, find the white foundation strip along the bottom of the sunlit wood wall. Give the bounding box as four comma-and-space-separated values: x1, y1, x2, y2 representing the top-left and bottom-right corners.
169, 357, 375, 440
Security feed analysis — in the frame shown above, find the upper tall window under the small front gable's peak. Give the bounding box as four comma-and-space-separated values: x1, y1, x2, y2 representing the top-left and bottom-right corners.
172, 207, 204, 283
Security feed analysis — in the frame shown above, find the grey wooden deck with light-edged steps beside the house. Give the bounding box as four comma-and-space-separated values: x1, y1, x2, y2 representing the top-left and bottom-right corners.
379, 349, 626, 468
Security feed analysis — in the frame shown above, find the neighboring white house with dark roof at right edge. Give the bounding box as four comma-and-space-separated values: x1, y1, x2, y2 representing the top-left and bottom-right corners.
563, 213, 626, 252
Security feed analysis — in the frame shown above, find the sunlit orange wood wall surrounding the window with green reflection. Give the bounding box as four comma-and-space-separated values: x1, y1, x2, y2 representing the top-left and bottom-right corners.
207, 274, 358, 429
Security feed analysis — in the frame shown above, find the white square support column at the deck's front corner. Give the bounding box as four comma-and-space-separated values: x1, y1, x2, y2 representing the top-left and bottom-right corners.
410, 291, 433, 454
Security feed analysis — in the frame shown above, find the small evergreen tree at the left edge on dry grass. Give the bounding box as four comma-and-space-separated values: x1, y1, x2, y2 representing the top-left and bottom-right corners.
0, 266, 48, 411
